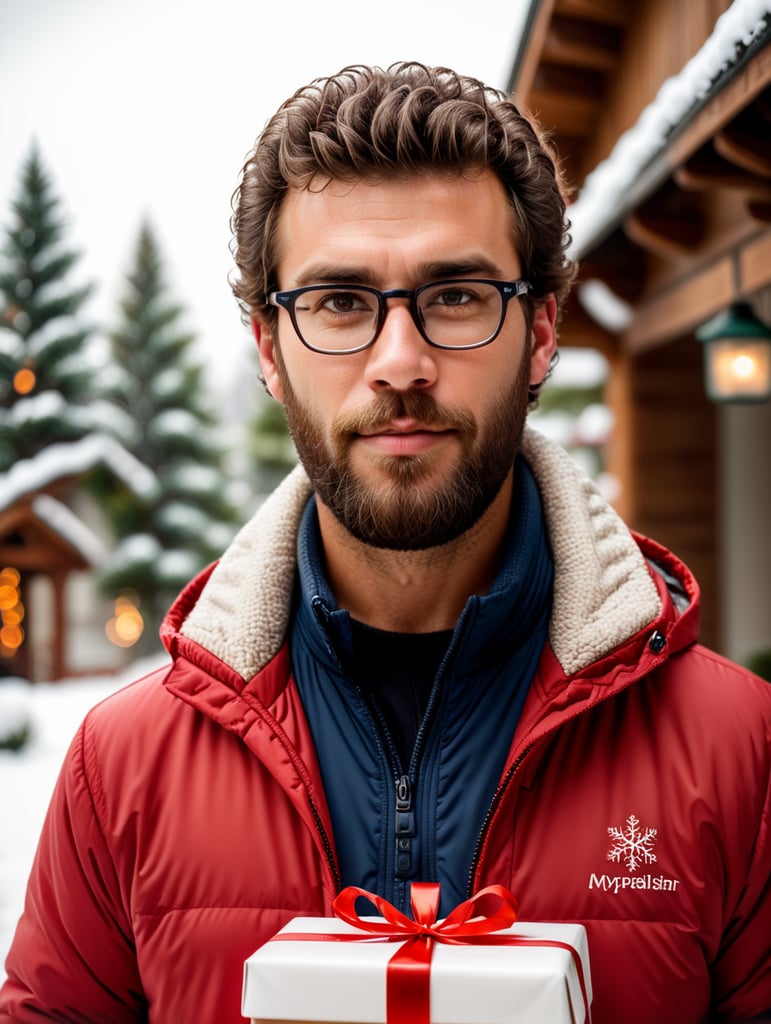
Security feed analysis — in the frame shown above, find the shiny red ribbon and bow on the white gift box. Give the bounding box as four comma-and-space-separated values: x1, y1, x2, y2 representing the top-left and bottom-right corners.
275, 882, 590, 1024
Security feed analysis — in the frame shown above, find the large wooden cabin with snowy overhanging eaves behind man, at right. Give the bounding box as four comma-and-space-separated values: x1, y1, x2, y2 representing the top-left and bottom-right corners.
509, 0, 771, 660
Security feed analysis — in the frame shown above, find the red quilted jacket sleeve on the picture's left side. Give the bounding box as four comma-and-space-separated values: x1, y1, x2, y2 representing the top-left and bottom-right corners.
0, 725, 147, 1024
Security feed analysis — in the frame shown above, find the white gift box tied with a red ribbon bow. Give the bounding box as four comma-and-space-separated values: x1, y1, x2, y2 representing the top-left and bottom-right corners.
242, 918, 592, 1024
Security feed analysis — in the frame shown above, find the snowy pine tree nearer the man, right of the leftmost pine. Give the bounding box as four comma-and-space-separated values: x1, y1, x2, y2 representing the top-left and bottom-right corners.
101, 224, 235, 641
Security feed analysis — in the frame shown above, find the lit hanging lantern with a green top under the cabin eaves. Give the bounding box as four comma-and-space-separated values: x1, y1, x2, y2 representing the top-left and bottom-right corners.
696, 302, 771, 402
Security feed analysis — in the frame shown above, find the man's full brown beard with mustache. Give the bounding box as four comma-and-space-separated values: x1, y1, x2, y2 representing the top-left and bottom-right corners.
276, 346, 530, 551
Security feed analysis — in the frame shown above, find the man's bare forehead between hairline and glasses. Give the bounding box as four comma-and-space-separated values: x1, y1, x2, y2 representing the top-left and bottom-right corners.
276, 170, 519, 289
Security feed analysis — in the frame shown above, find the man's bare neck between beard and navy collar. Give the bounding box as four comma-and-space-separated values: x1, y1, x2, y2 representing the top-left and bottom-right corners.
317, 473, 512, 633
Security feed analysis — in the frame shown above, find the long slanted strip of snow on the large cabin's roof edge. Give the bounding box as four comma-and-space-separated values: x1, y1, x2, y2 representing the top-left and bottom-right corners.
569, 0, 771, 258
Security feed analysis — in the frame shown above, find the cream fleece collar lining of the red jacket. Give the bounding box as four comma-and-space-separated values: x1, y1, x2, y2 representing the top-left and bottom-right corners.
181, 428, 661, 680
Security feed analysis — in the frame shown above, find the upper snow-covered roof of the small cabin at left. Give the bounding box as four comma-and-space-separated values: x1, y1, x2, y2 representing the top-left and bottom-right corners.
0, 434, 157, 511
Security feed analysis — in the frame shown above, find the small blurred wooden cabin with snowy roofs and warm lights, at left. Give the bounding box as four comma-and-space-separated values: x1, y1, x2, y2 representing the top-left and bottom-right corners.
0, 434, 156, 681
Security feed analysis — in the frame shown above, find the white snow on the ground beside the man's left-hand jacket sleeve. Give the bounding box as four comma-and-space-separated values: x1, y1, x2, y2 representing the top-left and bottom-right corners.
0, 655, 166, 982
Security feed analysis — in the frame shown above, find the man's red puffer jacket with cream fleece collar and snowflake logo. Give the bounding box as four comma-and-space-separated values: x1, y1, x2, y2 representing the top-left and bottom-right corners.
0, 433, 771, 1024
